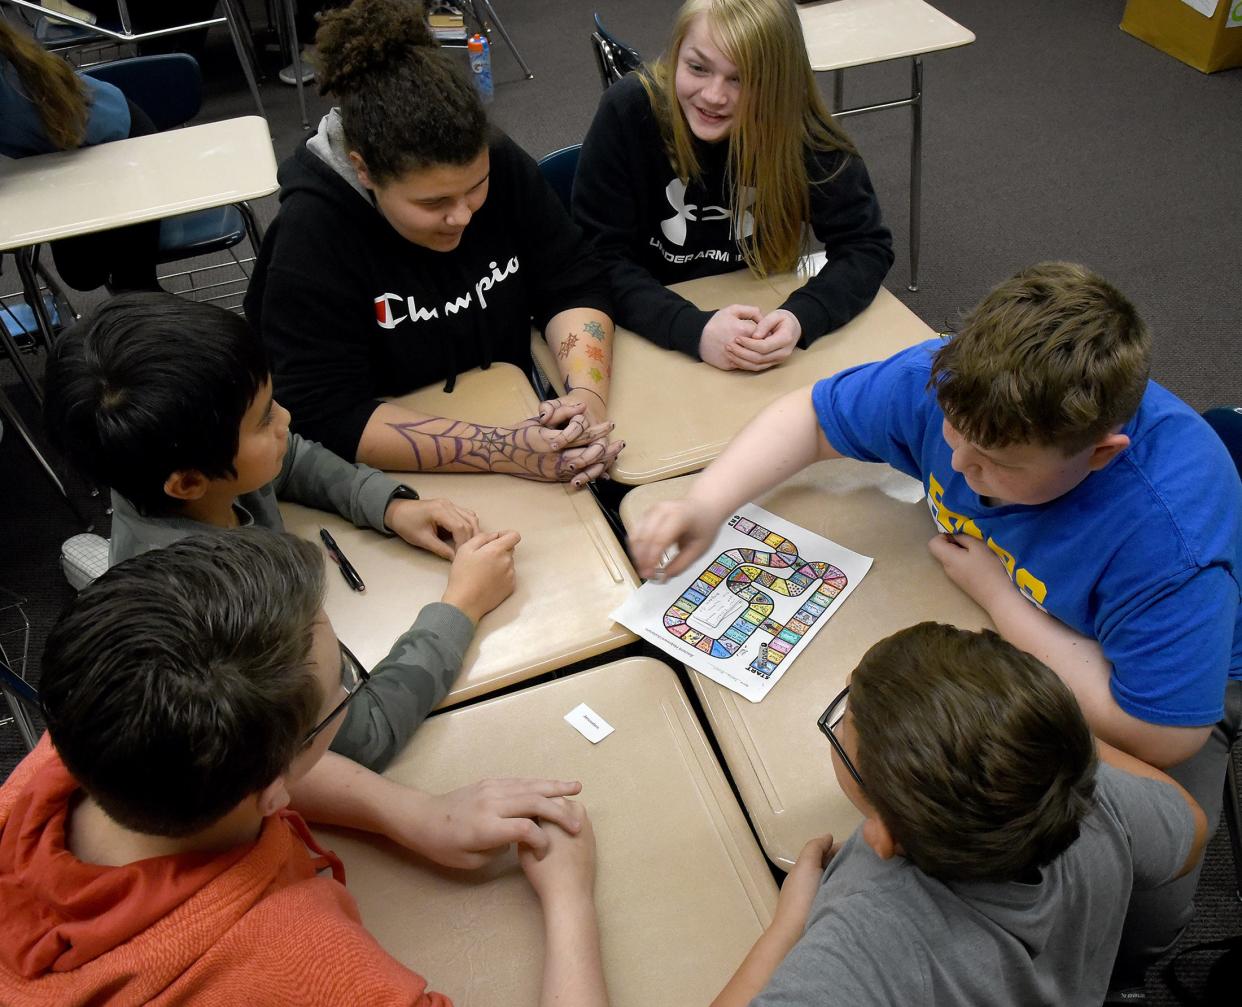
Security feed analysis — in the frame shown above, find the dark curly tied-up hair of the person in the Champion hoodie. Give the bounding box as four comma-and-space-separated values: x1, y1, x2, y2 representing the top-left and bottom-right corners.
315, 0, 487, 184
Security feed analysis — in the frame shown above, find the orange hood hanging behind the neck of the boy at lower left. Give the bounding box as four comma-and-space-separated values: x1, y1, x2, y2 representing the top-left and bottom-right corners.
0, 735, 343, 1003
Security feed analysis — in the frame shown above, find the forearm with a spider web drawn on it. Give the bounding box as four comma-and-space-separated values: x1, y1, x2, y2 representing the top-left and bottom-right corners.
358, 402, 555, 478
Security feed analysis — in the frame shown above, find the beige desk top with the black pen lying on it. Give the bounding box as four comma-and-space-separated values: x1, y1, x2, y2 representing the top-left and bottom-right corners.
281, 364, 637, 705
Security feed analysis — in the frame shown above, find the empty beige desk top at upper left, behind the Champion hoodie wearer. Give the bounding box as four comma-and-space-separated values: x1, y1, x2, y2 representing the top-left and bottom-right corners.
0, 115, 277, 250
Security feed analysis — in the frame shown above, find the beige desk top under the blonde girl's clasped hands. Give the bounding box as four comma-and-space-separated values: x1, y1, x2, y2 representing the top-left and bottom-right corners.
530, 271, 935, 485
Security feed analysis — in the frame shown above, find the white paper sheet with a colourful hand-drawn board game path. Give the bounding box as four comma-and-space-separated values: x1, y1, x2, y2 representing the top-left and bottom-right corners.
612, 504, 872, 703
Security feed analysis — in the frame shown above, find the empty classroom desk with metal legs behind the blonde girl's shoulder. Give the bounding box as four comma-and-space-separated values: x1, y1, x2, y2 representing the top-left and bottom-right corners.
797, 0, 975, 291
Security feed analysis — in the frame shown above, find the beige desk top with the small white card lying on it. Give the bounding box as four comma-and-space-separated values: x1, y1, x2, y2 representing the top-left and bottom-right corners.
312, 658, 776, 1007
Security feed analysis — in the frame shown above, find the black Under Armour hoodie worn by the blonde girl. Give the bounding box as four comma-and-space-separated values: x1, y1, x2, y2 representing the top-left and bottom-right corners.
574, 75, 893, 356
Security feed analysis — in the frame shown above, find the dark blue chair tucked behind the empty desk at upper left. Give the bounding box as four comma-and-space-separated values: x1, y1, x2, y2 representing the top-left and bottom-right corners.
82, 52, 263, 310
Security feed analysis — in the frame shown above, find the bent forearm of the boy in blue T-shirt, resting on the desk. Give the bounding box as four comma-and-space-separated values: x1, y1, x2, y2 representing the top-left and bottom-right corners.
985, 591, 1211, 767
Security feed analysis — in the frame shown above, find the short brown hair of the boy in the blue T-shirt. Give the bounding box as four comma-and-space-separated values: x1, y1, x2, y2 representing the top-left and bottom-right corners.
929, 262, 1151, 456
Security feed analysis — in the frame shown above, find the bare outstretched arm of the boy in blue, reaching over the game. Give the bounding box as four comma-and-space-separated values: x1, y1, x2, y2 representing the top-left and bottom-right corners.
630, 387, 841, 577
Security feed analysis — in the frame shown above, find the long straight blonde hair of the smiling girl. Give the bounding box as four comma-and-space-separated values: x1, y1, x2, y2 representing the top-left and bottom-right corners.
638, 0, 858, 276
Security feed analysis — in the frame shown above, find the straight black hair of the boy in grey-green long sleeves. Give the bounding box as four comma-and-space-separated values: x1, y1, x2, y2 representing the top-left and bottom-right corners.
43, 293, 271, 515
